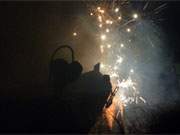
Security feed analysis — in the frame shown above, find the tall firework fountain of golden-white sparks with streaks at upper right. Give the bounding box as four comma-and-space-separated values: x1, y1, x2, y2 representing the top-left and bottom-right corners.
73, 1, 166, 106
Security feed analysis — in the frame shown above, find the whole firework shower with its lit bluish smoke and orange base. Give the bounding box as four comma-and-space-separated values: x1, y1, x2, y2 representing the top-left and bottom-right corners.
70, 0, 169, 132
